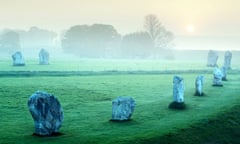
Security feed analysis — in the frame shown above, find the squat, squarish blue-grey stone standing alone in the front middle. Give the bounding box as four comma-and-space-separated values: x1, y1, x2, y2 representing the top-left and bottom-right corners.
111, 97, 135, 121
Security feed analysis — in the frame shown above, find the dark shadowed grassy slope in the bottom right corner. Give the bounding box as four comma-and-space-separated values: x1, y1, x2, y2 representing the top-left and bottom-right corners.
134, 105, 240, 144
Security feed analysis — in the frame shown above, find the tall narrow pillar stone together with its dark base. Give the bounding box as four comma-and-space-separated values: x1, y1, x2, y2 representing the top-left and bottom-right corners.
169, 76, 185, 109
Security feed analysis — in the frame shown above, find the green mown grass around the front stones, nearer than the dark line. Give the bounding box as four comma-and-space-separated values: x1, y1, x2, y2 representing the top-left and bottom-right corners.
0, 73, 240, 144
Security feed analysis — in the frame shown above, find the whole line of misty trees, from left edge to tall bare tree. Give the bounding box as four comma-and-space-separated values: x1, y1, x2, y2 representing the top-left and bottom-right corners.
0, 14, 174, 58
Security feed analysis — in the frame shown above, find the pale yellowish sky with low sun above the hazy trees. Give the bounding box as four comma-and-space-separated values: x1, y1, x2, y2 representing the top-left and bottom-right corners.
0, 0, 240, 49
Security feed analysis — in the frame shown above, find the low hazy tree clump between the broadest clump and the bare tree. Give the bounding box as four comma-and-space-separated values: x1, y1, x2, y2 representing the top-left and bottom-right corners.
121, 32, 154, 58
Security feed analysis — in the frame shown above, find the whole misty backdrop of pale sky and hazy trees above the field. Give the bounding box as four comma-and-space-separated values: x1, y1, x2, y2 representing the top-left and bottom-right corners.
0, 0, 240, 60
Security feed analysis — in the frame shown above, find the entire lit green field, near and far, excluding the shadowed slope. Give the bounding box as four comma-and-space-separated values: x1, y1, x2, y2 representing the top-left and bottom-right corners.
0, 59, 240, 144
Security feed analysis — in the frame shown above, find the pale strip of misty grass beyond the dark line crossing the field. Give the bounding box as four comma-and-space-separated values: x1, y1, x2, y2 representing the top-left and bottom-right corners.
0, 59, 236, 71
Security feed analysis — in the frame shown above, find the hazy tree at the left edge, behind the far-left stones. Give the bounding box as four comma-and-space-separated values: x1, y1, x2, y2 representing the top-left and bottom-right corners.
0, 30, 20, 54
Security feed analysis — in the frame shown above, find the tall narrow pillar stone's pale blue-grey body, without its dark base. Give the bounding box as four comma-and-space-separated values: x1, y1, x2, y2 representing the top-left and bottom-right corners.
173, 76, 184, 103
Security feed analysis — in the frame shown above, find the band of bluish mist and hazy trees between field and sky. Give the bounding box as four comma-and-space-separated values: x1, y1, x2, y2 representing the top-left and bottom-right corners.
0, 21, 240, 61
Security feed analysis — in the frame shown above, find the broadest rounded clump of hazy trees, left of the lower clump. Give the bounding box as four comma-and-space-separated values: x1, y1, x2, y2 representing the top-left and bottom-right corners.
62, 24, 121, 57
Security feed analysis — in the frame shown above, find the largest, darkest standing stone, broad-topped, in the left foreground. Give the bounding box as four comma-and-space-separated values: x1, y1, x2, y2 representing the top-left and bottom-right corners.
28, 91, 63, 136
